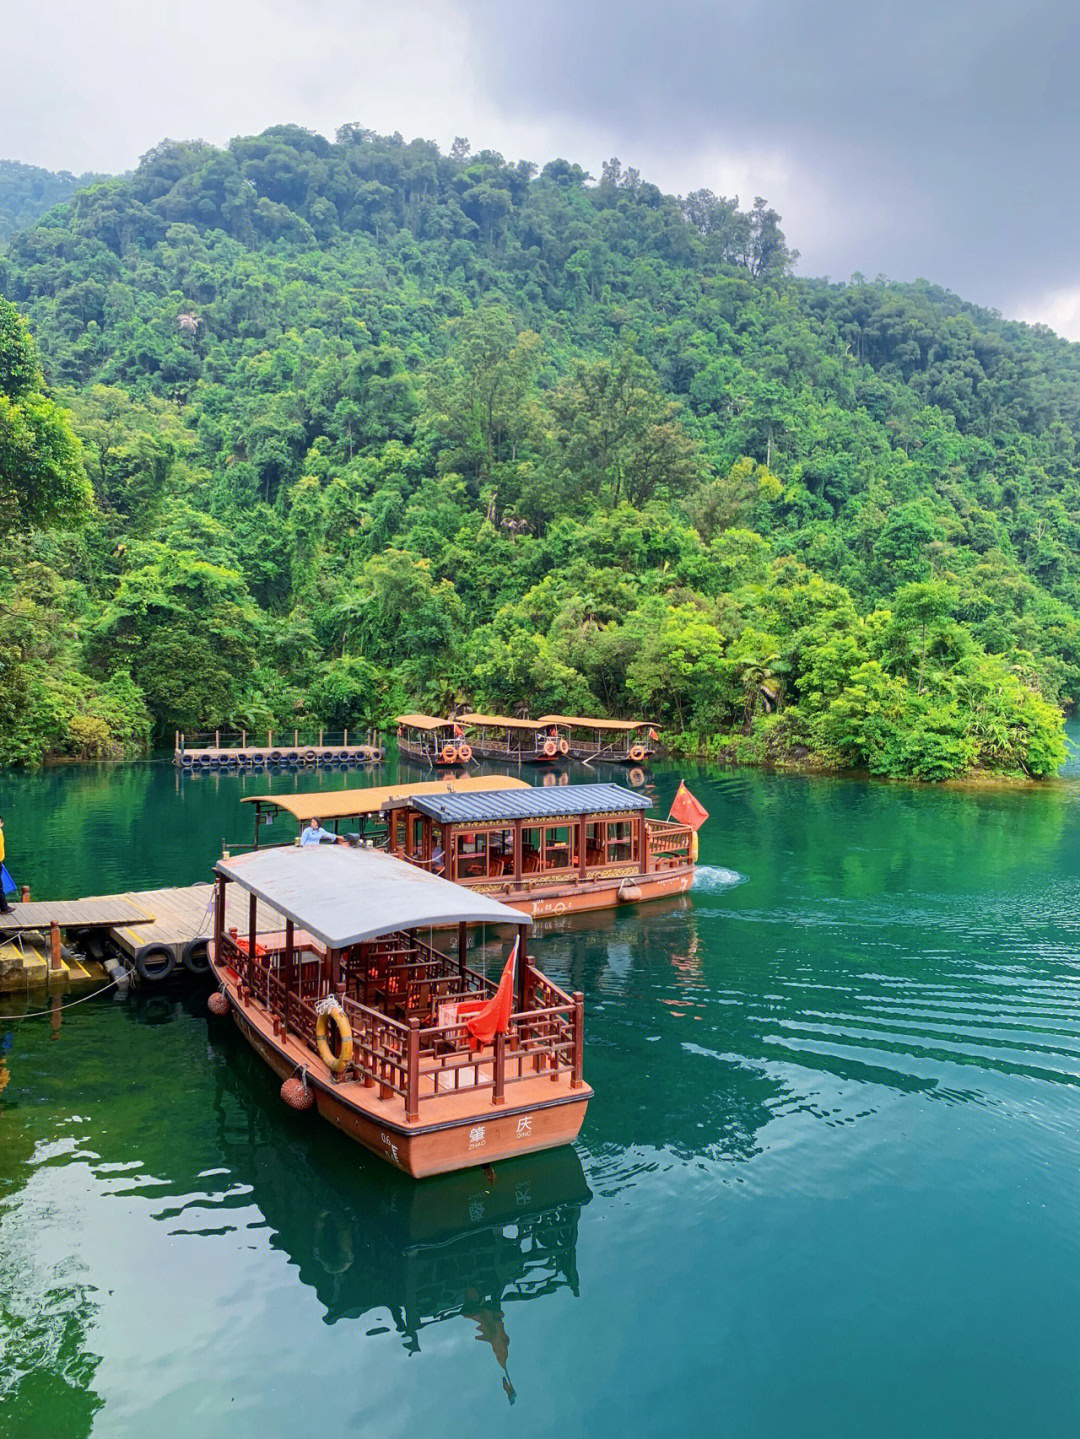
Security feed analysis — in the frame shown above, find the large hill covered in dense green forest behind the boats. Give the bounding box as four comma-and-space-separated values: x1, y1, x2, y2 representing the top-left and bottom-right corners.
0, 127, 1080, 778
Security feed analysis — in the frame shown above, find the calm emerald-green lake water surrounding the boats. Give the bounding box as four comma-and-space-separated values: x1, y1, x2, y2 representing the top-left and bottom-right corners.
0, 764, 1080, 1439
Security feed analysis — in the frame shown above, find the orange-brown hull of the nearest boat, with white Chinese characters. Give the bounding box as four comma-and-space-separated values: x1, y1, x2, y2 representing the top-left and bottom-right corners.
213, 964, 592, 1179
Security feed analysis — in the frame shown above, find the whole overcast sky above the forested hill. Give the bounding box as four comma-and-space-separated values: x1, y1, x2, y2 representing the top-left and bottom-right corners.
8, 0, 1080, 340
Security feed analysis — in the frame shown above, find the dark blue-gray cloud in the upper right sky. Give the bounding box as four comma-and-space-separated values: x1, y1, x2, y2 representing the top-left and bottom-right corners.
457, 0, 1080, 325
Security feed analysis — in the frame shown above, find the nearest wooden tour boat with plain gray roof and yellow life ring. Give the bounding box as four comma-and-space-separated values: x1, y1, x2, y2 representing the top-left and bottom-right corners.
210, 845, 592, 1177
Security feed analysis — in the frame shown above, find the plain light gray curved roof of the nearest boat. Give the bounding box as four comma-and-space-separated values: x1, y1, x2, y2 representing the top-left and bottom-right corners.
214, 845, 532, 950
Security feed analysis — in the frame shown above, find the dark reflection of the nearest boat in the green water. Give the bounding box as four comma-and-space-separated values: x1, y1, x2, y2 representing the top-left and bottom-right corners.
209, 1046, 592, 1400
